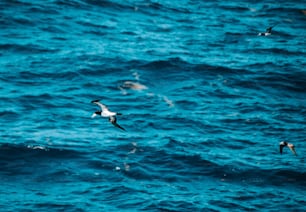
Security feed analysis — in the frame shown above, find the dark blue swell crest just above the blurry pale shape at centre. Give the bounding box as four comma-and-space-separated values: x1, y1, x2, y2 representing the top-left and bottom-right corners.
39, 55, 252, 79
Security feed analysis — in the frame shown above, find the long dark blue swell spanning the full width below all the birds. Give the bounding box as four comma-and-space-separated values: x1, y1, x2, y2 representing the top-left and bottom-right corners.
0, 140, 306, 188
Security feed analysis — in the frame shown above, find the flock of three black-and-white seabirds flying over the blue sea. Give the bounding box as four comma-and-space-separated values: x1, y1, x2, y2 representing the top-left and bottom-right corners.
91, 24, 297, 155
